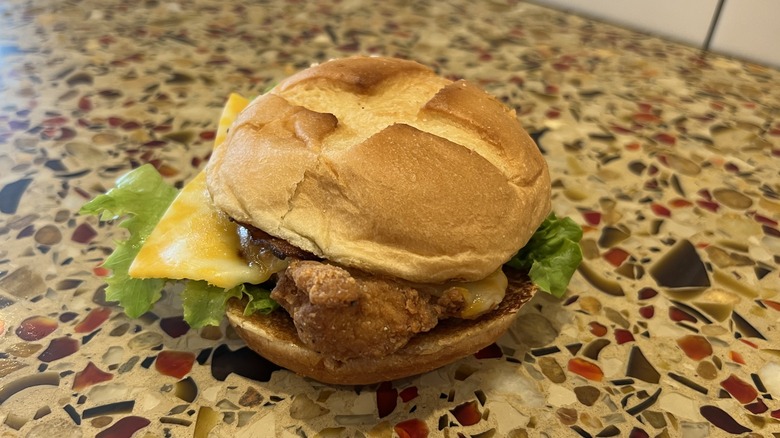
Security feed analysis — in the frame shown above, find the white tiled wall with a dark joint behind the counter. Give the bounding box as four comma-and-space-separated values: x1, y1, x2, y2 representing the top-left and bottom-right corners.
531, 0, 780, 67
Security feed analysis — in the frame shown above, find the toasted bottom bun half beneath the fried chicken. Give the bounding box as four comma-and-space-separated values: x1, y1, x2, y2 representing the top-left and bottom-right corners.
227, 270, 536, 385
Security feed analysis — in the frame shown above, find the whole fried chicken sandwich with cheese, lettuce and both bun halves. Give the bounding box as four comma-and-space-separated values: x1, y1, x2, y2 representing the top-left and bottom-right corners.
82, 56, 582, 384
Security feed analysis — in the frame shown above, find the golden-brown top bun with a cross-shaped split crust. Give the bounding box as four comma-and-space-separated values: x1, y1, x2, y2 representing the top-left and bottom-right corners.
206, 57, 550, 282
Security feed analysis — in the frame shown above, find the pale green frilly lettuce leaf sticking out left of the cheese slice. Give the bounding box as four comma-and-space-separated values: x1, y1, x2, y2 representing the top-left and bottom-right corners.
79, 164, 178, 318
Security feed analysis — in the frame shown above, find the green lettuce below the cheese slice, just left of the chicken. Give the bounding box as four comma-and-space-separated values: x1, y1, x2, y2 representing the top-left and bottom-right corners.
182, 280, 279, 328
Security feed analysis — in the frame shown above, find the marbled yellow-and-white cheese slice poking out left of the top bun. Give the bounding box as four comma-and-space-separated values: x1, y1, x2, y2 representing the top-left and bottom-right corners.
130, 94, 278, 288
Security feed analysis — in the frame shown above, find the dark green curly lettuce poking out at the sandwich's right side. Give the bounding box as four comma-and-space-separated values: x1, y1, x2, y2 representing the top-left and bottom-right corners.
507, 213, 582, 298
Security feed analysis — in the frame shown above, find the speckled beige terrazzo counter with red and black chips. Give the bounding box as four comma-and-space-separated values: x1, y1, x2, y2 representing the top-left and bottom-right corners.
0, 0, 780, 437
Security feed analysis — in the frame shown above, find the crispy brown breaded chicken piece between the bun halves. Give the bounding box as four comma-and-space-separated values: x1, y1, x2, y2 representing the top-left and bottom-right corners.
271, 260, 465, 360
